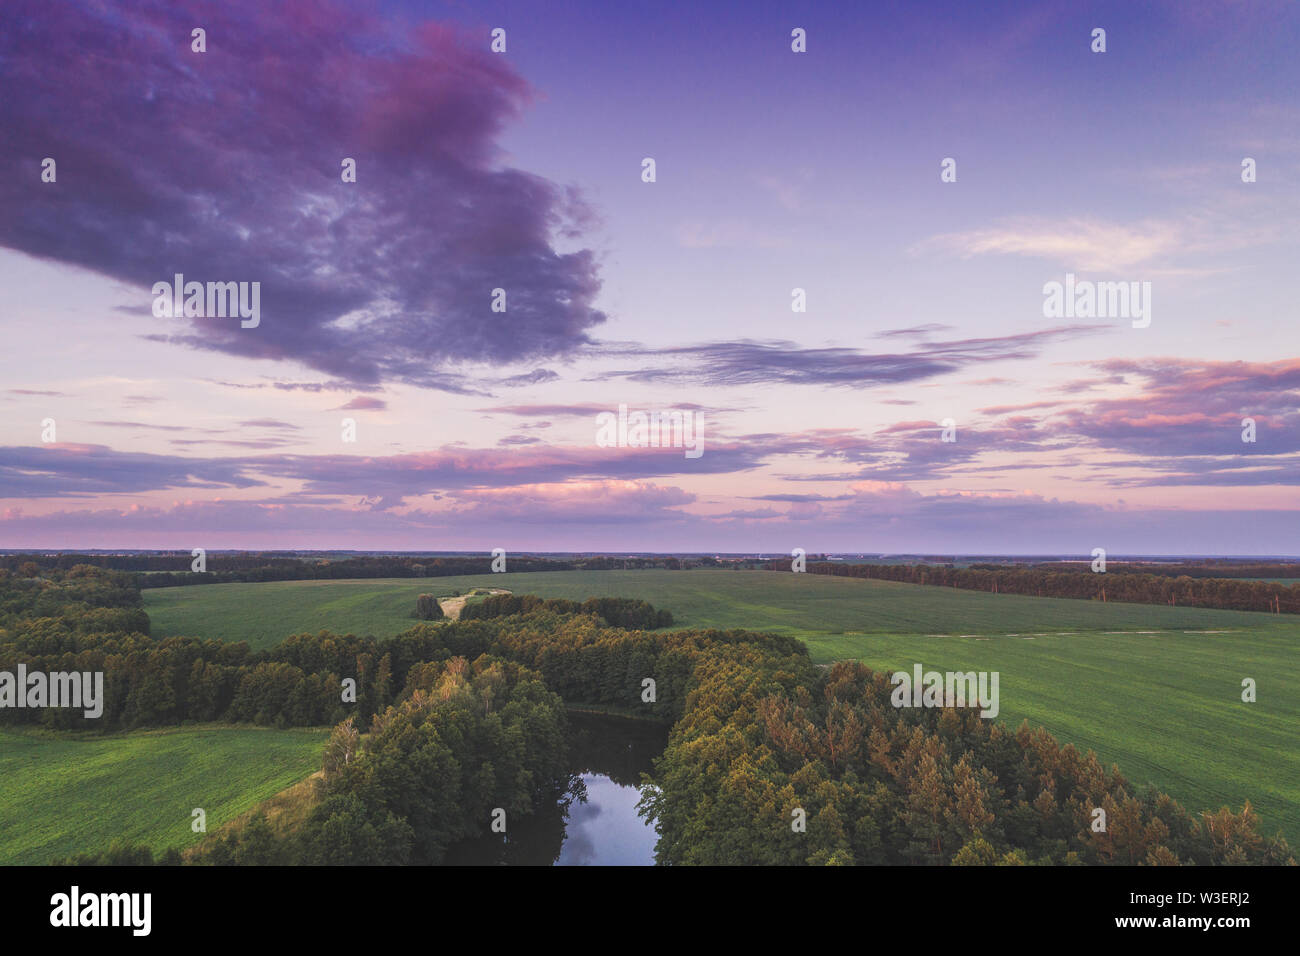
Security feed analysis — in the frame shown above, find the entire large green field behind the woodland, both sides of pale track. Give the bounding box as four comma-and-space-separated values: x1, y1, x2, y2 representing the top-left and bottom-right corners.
144, 570, 1300, 844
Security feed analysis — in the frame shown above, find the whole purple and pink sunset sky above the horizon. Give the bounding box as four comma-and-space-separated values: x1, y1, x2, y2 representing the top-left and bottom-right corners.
0, 0, 1300, 557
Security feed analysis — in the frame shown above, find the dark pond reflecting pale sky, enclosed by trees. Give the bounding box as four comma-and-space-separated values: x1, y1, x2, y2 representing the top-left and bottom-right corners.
446, 711, 668, 866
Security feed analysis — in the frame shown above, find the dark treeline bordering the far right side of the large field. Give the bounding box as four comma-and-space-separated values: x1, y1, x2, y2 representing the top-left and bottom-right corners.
766, 561, 1300, 614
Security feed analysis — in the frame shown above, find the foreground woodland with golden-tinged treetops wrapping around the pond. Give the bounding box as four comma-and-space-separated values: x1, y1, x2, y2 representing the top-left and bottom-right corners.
53, 590, 1294, 865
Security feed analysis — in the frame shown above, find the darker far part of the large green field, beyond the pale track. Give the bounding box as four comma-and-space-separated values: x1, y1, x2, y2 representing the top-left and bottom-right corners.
143, 568, 1300, 648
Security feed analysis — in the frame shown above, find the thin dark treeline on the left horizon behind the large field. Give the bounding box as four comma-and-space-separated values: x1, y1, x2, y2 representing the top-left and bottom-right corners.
0, 551, 702, 588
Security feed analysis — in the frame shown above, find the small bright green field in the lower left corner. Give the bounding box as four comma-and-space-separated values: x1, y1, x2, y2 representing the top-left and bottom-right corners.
0, 724, 329, 865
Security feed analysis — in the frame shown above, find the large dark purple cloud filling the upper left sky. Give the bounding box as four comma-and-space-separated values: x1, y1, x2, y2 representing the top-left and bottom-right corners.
0, 0, 605, 390
